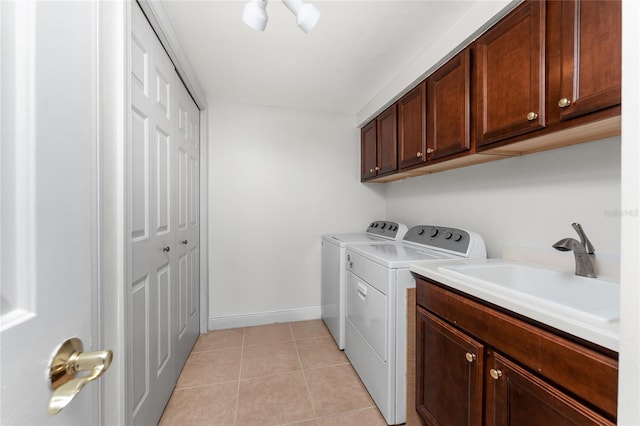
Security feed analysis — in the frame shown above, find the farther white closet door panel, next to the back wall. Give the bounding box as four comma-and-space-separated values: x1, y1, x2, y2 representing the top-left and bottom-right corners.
174, 80, 200, 366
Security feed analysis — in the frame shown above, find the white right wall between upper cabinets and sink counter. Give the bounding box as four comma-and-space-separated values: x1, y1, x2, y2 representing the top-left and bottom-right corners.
386, 137, 620, 265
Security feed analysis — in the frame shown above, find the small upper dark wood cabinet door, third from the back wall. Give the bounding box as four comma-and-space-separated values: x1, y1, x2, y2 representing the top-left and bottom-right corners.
398, 82, 427, 169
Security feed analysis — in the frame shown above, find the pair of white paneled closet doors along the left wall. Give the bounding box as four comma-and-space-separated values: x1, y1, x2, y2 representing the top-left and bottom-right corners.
126, 5, 200, 424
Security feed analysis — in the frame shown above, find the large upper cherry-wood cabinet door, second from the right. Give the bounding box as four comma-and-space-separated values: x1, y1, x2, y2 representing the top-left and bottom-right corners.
475, 0, 545, 146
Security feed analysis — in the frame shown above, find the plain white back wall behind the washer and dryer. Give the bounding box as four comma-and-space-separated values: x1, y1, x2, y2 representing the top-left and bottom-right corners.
209, 103, 385, 329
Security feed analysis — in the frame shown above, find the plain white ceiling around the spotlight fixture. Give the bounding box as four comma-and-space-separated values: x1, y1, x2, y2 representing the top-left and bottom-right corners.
163, 0, 477, 114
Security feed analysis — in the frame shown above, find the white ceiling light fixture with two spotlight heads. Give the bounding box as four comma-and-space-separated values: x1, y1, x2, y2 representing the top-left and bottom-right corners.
242, 0, 320, 33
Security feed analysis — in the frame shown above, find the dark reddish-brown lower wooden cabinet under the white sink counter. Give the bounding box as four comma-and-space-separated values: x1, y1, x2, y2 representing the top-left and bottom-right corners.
416, 278, 617, 426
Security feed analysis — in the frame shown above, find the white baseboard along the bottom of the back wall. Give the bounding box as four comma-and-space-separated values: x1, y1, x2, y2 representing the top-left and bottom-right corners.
209, 306, 322, 330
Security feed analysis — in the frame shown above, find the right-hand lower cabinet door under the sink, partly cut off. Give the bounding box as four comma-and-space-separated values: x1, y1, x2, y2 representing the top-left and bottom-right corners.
486, 353, 614, 426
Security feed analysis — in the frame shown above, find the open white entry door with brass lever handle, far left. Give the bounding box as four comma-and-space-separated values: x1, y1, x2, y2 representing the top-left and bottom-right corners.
0, 0, 104, 425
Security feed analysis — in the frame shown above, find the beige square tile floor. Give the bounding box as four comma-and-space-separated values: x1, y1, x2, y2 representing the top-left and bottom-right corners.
160, 320, 386, 426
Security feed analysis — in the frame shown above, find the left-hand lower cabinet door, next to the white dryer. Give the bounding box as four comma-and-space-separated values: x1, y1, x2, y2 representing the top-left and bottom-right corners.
416, 306, 483, 426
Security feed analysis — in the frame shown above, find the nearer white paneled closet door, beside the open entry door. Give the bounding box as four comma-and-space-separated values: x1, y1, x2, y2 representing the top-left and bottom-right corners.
127, 6, 178, 424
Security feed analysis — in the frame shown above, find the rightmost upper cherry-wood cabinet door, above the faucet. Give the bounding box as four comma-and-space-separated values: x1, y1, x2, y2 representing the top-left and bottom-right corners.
557, 0, 622, 120
